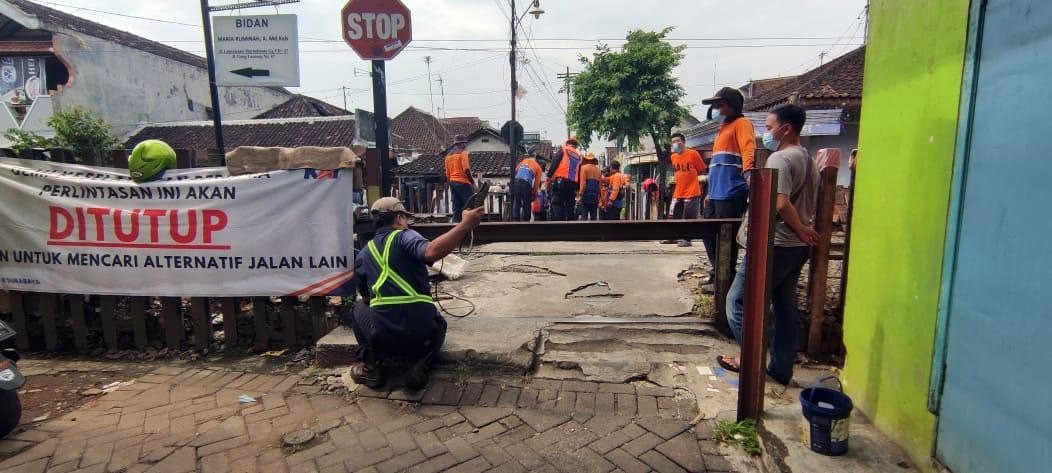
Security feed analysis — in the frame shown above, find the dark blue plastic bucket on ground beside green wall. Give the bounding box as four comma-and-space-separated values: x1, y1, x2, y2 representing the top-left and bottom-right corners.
800, 376, 854, 456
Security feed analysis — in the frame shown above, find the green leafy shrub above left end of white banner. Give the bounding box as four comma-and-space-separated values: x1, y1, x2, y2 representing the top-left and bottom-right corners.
3, 107, 120, 158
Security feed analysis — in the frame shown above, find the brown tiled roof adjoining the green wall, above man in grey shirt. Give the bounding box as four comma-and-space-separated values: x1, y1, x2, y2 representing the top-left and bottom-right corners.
745, 46, 866, 111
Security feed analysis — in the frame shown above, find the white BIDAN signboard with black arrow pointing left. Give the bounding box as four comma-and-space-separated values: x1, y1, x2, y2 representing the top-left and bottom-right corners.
211, 15, 300, 87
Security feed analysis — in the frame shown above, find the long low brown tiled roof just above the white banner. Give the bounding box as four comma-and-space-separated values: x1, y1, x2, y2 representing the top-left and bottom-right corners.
125, 117, 356, 149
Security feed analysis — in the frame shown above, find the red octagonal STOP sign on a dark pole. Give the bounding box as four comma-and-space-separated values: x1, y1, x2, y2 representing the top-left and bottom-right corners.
340, 0, 412, 61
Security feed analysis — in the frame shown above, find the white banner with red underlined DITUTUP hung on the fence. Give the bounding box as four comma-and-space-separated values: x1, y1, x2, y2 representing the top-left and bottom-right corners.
0, 159, 355, 296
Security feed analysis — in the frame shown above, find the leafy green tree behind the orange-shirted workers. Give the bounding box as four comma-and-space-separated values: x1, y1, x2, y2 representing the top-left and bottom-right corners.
567, 27, 687, 161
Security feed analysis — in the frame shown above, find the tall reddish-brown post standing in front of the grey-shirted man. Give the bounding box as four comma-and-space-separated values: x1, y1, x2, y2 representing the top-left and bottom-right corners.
737, 169, 777, 421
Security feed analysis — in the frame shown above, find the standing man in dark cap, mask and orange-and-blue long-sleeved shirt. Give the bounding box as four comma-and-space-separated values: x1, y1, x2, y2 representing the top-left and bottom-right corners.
702, 87, 756, 293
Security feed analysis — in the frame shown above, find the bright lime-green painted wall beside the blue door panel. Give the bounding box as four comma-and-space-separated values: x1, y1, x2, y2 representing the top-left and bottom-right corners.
844, 0, 969, 470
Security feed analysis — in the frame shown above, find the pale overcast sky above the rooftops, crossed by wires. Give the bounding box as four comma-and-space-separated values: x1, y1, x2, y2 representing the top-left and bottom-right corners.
38, 0, 866, 148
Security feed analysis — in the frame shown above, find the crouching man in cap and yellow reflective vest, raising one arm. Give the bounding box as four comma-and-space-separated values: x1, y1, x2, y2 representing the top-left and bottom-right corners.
350, 198, 484, 389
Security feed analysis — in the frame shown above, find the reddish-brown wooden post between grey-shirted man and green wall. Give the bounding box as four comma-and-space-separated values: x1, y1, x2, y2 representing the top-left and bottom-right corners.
807, 166, 839, 357
